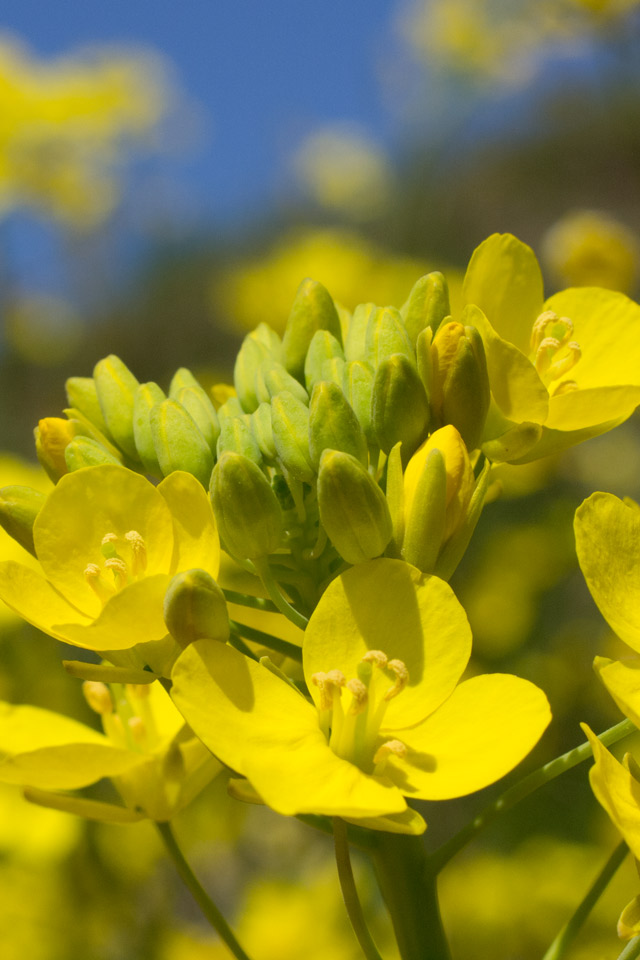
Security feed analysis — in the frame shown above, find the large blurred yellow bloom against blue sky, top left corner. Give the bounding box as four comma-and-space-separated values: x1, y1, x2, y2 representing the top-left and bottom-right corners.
0, 37, 168, 228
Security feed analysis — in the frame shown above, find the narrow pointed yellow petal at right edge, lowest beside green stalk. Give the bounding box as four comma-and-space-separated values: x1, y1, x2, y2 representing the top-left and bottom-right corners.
581, 723, 640, 858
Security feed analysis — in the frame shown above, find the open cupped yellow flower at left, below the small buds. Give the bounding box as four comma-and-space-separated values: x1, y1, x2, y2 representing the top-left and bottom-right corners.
0, 465, 220, 651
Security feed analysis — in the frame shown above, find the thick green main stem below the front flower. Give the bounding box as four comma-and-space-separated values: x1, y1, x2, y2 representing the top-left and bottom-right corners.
373, 832, 451, 960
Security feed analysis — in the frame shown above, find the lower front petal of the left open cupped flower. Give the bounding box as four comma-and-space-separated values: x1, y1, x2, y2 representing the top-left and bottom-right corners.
53, 574, 171, 650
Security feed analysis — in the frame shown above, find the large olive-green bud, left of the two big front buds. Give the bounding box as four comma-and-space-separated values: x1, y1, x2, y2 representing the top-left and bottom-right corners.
209, 453, 283, 560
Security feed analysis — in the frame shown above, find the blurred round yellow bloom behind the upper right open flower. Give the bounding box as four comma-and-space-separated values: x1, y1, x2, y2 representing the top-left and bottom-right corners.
542, 210, 640, 294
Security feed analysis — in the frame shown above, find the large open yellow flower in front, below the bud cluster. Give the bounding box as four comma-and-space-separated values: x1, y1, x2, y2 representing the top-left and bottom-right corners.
172, 559, 550, 833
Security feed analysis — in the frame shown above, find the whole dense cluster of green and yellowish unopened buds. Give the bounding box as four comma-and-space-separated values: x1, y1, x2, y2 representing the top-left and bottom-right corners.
8, 273, 490, 607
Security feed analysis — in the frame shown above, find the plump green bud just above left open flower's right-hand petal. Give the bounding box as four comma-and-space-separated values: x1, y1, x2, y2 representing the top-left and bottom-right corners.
149, 400, 213, 487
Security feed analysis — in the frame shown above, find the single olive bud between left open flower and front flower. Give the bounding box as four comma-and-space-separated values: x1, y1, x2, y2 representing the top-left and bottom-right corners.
164, 570, 229, 649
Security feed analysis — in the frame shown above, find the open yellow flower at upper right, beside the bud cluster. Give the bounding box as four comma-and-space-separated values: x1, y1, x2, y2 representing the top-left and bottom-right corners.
463, 233, 640, 462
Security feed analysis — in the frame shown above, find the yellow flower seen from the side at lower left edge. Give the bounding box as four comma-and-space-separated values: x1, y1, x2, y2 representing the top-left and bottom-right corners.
0, 681, 222, 823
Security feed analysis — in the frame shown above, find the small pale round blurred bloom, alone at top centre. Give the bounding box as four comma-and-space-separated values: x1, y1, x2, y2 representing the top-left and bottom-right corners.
293, 127, 391, 220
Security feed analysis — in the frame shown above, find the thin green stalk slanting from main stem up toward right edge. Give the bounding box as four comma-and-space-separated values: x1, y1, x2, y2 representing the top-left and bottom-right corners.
429, 720, 637, 873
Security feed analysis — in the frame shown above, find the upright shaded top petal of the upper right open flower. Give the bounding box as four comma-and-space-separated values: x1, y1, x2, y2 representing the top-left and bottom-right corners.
463, 233, 543, 353
